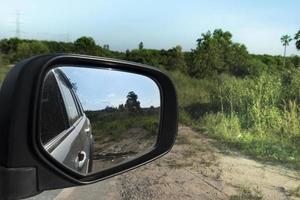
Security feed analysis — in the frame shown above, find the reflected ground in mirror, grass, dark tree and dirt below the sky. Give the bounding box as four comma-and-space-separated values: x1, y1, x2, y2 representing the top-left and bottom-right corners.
85, 91, 160, 170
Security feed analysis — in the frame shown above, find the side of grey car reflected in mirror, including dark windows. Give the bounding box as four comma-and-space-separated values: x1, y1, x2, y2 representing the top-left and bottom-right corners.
40, 69, 93, 174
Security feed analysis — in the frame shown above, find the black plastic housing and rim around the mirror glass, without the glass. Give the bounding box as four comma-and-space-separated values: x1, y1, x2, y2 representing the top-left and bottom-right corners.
0, 54, 178, 199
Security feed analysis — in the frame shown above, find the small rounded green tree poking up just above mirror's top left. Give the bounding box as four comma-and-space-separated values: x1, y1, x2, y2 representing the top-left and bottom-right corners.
74, 36, 97, 55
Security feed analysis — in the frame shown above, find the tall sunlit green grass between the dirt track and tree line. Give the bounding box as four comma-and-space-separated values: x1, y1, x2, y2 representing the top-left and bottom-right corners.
170, 70, 300, 170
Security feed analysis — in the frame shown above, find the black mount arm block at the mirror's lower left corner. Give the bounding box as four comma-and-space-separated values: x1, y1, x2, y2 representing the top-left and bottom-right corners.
0, 166, 40, 199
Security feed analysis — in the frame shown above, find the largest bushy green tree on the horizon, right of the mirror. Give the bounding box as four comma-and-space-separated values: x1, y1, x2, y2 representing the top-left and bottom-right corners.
188, 29, 248, 78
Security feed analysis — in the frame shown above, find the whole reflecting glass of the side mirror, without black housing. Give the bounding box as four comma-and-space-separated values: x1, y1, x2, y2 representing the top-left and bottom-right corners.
39, 66, 161, 175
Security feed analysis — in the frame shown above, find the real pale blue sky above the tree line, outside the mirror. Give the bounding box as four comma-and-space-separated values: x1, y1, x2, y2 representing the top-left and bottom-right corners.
0, 0, 300, 55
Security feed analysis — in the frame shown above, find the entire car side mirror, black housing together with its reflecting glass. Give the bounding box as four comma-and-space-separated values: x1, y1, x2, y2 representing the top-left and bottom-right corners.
0, 54, 178, 199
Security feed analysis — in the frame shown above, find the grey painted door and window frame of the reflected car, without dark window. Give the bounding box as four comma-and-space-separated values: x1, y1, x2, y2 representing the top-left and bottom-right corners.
44, 69, 93, 174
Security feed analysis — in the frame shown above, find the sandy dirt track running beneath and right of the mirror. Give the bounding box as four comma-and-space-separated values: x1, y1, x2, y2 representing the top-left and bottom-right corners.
28, 126, 300, 200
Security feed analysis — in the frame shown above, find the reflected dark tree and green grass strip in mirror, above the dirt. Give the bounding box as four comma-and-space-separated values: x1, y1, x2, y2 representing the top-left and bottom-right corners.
85, 91, 160, 141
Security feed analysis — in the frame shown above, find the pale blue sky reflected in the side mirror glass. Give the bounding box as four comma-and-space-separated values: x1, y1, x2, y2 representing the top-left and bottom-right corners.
60, 67, 160, 110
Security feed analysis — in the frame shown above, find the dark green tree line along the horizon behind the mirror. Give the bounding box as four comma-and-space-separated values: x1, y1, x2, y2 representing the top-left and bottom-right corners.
0, 29, 300, 78
